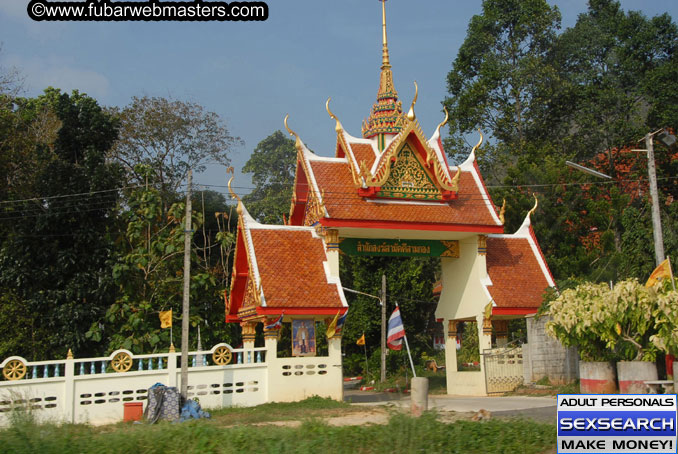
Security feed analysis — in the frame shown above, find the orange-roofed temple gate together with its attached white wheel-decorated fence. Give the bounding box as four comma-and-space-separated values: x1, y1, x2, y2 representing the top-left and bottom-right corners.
0, 2, 554, 424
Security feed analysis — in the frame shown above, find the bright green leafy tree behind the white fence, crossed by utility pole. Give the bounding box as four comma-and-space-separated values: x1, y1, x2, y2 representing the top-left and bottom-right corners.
87, 174, 239, 353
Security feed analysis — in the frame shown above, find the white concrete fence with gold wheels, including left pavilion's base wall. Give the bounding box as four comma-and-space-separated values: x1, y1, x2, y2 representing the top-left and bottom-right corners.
0, 339, 343, 426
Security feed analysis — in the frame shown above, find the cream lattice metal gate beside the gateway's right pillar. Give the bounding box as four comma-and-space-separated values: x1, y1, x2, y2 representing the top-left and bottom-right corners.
483, 345, 524, 394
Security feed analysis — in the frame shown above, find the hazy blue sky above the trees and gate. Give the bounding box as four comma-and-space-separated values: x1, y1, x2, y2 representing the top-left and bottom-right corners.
0, 0, 678, 193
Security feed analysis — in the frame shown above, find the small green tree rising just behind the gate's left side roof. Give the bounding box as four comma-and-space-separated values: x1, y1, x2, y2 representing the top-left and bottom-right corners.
242, 131, 297, 224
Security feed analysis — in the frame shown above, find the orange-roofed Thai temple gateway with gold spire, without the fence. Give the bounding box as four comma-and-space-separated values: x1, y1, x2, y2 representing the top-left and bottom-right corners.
226, 2, 554, 401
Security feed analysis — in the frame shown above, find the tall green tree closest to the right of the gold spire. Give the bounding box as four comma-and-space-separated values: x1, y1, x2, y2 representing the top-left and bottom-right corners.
443, 0, 560, 167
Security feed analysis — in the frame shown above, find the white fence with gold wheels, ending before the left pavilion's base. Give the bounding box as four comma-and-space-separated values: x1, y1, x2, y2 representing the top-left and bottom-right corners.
0, 344, 267, 425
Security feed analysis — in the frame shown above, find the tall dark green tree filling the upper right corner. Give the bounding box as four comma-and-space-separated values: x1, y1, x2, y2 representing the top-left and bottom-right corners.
541, 0, 678, 167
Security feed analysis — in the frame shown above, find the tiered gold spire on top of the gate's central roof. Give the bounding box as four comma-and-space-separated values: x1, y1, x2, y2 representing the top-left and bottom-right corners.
362, 0, 404, 139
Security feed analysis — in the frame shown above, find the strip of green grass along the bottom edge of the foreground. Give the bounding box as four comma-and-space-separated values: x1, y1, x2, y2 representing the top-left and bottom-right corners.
0, 408, 556, 454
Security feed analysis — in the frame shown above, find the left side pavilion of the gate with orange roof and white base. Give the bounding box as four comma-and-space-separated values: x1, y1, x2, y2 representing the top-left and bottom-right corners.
226, 200, 348, 402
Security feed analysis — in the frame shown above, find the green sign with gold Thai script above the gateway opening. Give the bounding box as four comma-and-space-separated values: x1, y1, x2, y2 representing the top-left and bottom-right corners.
339, 238, 459, 258
